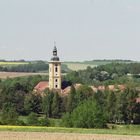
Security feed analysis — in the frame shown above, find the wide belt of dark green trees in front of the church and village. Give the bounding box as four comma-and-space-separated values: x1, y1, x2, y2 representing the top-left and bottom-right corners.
0, 76, 140, 128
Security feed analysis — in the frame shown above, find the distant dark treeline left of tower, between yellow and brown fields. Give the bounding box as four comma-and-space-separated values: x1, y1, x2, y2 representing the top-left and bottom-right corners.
0, 61, 49, 72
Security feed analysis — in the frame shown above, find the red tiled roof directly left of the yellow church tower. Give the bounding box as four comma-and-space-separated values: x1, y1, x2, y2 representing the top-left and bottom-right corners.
34, 81, 49, 91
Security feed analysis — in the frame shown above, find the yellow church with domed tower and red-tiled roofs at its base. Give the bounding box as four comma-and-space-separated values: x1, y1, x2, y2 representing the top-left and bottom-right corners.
34, 45, 81, 96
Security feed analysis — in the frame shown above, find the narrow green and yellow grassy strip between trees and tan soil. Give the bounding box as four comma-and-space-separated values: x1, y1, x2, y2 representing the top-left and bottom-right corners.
0, 125, 140, 136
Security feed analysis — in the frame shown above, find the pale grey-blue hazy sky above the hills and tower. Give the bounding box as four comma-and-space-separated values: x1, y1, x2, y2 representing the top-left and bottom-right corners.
0, 0, 140, 61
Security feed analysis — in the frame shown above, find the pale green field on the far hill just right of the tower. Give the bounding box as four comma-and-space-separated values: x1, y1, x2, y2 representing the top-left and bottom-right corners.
64, 62, 97, 71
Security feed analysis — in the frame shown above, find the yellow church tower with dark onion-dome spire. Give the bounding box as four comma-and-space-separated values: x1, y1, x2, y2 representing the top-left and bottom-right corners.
49, 45, 61, 90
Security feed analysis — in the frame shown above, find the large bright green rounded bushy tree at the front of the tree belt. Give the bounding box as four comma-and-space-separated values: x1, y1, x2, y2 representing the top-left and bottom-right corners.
63, 100, 107, 128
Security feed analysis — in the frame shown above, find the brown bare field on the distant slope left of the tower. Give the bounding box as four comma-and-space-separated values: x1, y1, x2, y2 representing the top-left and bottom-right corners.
0, 72, 48, 79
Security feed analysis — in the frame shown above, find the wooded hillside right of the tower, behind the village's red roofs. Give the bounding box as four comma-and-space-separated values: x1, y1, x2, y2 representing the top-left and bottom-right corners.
65, 63, 140, 84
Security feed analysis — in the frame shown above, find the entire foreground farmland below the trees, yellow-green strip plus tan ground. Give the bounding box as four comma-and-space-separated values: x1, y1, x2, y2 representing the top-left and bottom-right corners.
0, 126, 140, 140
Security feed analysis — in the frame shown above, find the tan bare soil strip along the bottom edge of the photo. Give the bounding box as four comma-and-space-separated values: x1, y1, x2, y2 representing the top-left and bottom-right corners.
0, 131, 140, 140
